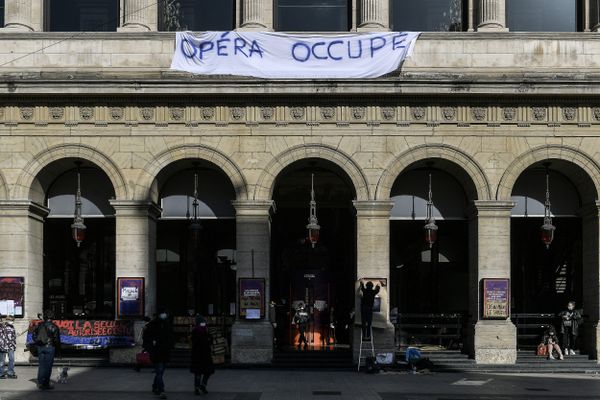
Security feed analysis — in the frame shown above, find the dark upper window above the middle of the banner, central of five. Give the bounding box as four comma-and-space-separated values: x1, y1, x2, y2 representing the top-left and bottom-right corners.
275, 0, 351, 32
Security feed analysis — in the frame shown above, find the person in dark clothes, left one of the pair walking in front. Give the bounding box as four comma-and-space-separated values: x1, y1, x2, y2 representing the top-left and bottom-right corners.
142, 309, 173, 399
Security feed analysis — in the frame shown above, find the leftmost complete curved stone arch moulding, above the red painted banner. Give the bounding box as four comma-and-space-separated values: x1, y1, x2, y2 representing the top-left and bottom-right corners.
14, 143, 129, 199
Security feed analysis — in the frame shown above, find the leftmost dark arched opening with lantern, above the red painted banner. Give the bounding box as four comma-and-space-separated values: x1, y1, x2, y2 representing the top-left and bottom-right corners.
31, 158, 115, 320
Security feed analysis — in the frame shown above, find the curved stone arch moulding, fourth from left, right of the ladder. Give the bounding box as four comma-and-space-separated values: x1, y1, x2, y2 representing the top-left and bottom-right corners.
375, 144, 492, 200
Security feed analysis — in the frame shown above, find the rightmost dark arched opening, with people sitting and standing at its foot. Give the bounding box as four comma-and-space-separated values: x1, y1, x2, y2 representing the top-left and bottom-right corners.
511, 160, 597, 350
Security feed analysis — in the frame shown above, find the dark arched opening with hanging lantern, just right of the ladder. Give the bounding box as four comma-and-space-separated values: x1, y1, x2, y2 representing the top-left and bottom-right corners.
390, 159, 477, 350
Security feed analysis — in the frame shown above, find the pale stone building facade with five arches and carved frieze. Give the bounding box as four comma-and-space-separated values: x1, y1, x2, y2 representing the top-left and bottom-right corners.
0, 0, 600, 363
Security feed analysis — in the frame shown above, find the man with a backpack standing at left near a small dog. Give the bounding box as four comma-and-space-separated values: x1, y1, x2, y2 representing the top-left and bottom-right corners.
32, 310, 61, 390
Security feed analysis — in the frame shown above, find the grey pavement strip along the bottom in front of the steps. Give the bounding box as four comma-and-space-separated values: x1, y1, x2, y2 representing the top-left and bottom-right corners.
0, 367, 600, 400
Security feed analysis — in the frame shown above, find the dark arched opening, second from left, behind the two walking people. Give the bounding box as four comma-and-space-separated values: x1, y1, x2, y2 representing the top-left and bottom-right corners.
154, 159, 236, 353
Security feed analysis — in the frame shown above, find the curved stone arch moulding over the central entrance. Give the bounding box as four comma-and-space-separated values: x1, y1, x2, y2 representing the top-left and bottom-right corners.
254, 144, 370, 200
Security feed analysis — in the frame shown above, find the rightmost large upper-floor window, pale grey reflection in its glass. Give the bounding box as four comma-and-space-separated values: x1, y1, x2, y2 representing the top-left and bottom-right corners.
506, 0, 581, 32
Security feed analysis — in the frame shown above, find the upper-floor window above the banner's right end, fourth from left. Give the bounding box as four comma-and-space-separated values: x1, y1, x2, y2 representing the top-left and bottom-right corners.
390, 0, 468, 32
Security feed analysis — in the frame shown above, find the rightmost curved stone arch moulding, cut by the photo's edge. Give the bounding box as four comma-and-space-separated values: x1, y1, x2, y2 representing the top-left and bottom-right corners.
496, 145, 600, 200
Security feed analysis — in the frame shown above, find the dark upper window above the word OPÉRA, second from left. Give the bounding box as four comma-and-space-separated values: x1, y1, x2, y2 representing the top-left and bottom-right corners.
158, 0, 235, 31
